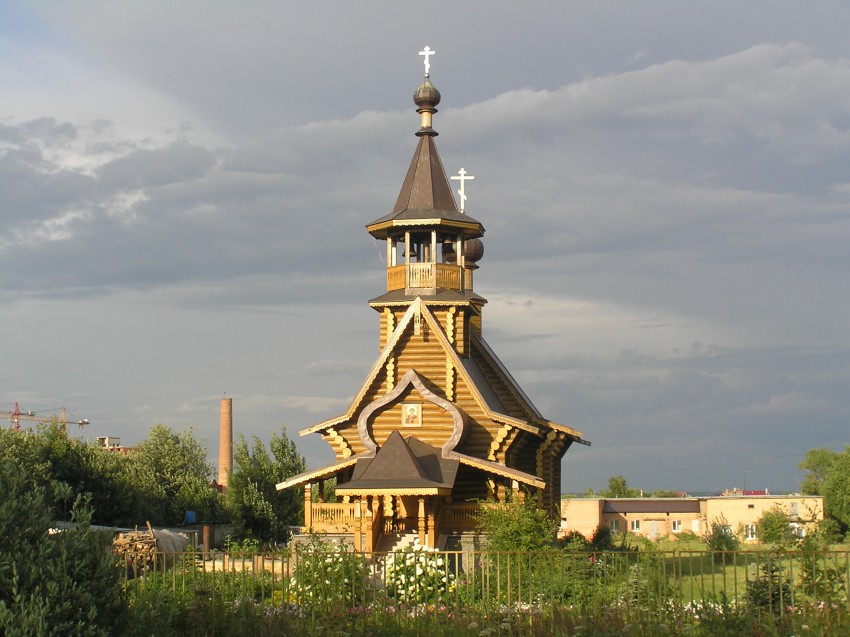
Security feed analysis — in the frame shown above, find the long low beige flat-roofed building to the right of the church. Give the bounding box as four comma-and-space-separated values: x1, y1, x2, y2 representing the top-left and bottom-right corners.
559, 494, 823, 542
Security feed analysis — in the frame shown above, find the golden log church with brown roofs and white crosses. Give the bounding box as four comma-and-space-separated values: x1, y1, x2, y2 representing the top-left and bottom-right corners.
278, 47, 587, 552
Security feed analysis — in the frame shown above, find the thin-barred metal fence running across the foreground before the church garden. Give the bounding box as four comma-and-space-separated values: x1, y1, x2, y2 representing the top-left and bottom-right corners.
125, 545, 850, 617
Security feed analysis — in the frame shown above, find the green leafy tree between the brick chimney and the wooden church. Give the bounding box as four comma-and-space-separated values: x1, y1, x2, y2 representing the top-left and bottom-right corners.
227, 426, 305, 542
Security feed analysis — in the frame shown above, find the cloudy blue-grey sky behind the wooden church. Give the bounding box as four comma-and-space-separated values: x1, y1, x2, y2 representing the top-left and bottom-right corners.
0, 0, 850, 493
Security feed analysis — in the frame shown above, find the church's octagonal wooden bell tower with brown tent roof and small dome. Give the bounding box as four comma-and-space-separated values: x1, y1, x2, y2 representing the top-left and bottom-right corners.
366, 60, 487, 355
